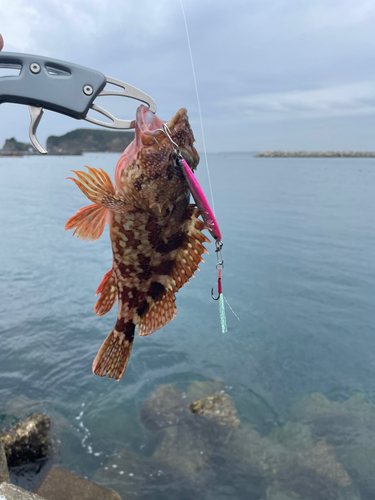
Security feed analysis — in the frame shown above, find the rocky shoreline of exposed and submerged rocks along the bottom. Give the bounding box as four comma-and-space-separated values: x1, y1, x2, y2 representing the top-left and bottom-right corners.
0, 380, 375, 500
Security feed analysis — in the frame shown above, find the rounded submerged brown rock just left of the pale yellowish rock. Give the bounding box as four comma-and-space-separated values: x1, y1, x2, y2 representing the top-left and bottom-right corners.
141, 384, 189, 431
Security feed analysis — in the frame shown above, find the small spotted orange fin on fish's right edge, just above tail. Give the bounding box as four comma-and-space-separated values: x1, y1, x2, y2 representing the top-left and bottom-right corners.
137, 290, 177, 336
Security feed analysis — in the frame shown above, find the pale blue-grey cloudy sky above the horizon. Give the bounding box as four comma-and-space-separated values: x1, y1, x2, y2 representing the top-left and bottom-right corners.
0, 0, 375, 152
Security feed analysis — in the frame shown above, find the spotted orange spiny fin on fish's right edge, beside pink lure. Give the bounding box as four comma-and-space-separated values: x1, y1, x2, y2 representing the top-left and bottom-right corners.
170, 205, 211, 292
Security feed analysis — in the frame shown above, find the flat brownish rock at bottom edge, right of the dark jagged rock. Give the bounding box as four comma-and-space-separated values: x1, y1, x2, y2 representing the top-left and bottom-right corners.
35, 468, 121, 500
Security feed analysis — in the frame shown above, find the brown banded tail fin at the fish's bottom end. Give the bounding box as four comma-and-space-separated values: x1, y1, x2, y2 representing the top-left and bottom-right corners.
92, 325, 135, 380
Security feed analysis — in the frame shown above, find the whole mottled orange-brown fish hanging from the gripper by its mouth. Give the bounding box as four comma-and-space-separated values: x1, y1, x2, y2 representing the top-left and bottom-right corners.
65, 105, 210, 381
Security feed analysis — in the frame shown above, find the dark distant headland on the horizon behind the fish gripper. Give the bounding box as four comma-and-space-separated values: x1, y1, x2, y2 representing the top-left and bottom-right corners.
0, 128, 134, 156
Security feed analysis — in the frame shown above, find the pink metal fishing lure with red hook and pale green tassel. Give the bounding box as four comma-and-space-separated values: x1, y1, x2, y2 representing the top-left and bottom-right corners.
162, 124, 239, 333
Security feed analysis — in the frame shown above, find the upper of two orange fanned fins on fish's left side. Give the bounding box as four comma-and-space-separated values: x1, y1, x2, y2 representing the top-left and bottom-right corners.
68, 167, 134, 213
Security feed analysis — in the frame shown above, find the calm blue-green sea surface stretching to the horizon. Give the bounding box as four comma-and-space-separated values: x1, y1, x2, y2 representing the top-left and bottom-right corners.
0, 154, 375, 500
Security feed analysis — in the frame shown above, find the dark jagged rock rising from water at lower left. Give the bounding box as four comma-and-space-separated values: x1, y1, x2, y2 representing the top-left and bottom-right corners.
0, 413, 51, 467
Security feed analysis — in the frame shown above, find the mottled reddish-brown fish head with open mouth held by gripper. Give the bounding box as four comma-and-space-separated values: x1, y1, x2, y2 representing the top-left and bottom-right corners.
115, 105, 199, 215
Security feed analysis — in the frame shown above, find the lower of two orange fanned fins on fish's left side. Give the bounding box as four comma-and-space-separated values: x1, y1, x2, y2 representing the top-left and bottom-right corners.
65, 203, 109, 241
